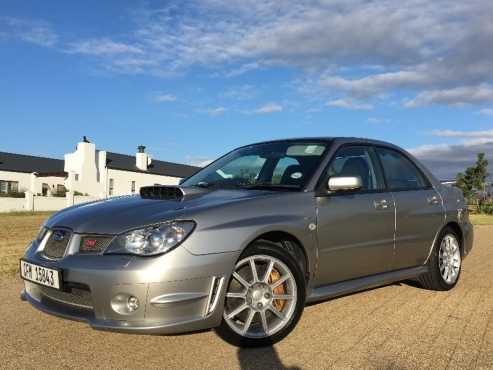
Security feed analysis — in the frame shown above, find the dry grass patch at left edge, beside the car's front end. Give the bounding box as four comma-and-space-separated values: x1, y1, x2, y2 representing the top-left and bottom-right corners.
0, 212, 52, 275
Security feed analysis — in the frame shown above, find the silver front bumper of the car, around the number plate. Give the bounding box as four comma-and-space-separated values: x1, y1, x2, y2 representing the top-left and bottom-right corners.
21, 244, 239, 334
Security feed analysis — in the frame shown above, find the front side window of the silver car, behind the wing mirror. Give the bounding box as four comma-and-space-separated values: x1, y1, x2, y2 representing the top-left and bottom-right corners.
326, 146, 385, 191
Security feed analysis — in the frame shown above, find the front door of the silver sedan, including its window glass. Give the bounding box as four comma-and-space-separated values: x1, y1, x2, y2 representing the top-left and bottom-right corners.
317, 146, 395, 285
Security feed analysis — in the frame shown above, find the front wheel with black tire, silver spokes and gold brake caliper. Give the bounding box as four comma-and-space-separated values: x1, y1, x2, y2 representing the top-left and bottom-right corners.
215, 240, 306, 347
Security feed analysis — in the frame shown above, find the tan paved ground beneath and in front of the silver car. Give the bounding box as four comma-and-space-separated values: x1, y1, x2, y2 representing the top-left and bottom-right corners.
0, 226, 493, 369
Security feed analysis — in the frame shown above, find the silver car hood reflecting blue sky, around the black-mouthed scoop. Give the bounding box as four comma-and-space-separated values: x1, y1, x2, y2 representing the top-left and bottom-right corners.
46, 189, 274, 235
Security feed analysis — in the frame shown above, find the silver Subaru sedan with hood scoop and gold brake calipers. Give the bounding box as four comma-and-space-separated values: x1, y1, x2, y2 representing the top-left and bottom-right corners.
20, 138, 473, 346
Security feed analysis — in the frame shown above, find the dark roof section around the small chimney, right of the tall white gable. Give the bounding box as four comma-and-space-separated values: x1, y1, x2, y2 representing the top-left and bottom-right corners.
106, 152, 200, 177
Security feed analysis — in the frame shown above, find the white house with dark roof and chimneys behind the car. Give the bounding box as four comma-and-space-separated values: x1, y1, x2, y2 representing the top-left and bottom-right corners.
0, 138, 199, 198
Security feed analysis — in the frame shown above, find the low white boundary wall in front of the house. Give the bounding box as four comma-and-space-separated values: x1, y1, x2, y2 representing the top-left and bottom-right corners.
0, 193, 98, 213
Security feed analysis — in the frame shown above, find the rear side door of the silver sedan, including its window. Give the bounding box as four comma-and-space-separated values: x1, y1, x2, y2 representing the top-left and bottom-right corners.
376, 147, 444, 269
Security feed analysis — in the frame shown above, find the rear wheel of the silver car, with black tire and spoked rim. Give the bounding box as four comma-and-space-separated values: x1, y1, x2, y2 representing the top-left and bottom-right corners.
419, 227, 462, 291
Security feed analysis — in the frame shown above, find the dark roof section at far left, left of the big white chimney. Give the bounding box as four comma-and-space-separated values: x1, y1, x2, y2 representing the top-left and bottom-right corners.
0, 152, 65, 176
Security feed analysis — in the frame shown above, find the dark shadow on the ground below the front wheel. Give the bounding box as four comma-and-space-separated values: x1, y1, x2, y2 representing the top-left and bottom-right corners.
238, 346, 301, 370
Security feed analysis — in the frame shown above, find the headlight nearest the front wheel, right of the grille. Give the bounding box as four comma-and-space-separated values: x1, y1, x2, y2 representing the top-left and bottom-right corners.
106, 221, 195, 256
